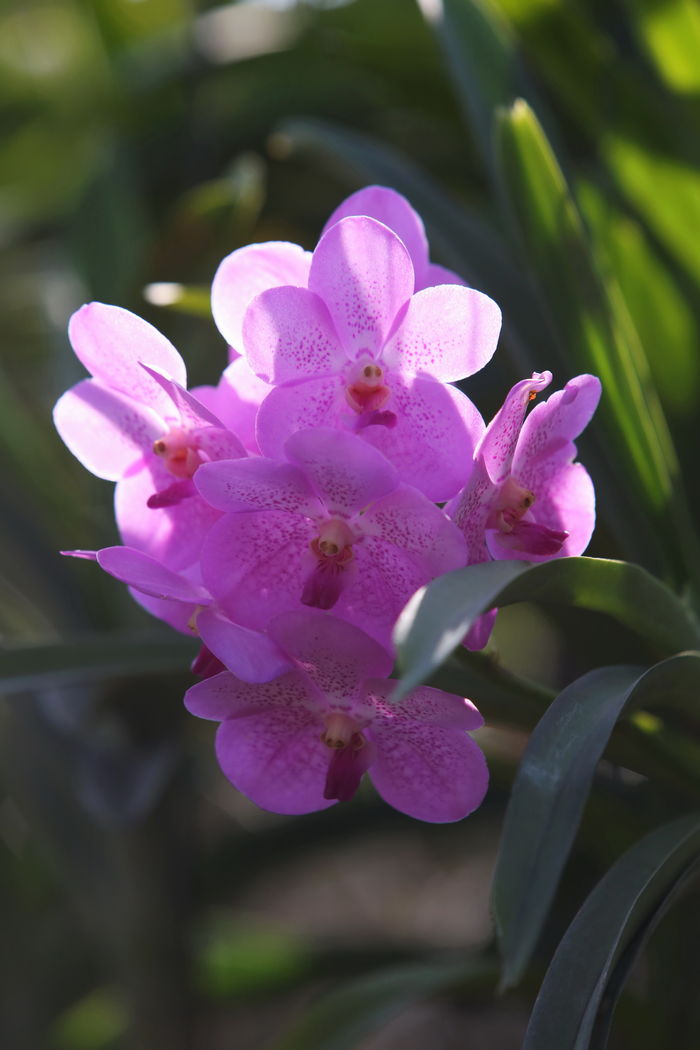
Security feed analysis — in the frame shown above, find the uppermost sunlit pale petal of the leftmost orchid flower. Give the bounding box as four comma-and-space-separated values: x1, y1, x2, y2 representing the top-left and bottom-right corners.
68, 302, 187, 418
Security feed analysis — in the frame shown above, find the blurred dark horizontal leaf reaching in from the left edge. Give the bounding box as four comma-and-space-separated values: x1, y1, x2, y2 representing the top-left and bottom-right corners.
0, 634, 196, 695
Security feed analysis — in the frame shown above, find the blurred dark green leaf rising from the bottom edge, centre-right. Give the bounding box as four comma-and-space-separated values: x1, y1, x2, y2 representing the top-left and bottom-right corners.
270, 958, 493, 1050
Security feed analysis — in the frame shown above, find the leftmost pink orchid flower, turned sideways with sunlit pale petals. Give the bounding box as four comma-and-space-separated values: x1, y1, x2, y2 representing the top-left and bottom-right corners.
54, 302, 247, 568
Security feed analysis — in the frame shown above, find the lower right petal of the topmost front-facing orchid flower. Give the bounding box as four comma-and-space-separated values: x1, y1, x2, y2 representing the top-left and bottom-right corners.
362, 374, 484, 503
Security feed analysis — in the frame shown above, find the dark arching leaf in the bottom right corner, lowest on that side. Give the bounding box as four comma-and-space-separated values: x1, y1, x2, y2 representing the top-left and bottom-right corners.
523, 813, 700, 1050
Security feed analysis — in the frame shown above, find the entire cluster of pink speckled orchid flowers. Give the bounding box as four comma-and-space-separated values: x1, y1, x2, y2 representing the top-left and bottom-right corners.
55, 187, 600, 822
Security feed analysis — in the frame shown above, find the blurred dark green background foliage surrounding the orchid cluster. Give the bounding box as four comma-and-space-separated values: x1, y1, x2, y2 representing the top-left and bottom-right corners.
0, 0, 700, 1050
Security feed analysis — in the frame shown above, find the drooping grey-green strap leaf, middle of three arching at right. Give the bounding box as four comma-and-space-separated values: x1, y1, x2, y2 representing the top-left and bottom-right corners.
493, 652, 700, 987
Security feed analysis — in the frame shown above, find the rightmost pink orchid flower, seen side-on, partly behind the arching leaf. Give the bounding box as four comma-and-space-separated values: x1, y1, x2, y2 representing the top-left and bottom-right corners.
445, 372, 600, 649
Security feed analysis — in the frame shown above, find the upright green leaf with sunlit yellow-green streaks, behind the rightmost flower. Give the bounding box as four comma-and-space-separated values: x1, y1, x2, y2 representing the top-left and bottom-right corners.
496, 100, 700, 584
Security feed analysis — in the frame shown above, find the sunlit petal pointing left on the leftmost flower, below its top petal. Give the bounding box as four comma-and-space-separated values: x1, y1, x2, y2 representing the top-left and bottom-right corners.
54, 379, 164, 481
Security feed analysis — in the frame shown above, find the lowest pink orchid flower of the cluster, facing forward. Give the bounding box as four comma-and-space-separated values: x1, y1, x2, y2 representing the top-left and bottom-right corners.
185, 610, 488, 823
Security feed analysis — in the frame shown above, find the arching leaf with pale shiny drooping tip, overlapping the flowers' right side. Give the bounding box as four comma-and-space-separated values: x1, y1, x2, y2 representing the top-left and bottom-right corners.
394, 558, 700, 698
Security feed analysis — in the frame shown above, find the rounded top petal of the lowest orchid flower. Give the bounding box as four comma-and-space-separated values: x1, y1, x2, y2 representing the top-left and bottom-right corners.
270, 610, 393, 711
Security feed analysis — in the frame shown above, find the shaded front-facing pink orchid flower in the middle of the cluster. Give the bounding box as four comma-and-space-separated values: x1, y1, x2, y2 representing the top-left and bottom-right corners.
195, 427, 465, 645
